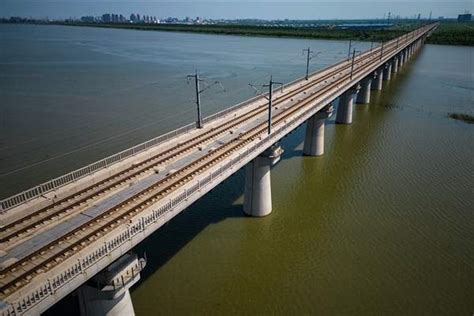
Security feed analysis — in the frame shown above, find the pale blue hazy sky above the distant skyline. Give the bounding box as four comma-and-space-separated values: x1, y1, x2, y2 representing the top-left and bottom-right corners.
0, 0, 474, 20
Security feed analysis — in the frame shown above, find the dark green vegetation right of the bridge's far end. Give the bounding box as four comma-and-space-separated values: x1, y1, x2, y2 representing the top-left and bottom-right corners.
427, 21, 474, 46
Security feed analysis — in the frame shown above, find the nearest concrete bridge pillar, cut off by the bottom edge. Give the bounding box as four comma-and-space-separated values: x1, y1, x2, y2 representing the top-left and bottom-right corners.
77, 253, 146, 316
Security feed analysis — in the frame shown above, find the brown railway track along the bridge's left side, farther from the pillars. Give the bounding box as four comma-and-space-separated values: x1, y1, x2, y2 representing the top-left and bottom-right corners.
0, 32, 408, 249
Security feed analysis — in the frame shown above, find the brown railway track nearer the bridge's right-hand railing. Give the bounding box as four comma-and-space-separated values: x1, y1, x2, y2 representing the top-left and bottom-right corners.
0, 27, 420, 297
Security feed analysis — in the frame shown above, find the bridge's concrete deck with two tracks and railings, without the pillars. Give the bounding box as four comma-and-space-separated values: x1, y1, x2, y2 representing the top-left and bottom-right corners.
0, 25, 435, 315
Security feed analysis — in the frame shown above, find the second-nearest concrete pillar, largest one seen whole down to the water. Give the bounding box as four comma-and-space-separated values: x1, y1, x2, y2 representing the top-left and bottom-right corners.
244, 145, 283, 217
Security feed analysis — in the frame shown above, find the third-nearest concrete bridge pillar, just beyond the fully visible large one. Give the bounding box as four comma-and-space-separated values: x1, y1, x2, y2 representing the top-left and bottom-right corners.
303, 104, 334, 156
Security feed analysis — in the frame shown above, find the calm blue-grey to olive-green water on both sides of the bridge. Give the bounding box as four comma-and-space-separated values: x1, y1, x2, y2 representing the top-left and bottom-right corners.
0, 26, 474, 315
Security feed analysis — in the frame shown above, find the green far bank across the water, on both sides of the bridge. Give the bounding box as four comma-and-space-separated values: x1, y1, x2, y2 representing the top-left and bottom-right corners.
52, 22, 474, 46
